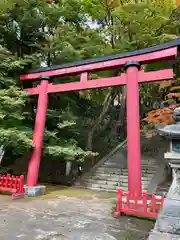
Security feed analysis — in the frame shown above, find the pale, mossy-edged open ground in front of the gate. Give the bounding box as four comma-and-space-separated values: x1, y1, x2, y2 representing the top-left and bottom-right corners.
0, 187, 153, 240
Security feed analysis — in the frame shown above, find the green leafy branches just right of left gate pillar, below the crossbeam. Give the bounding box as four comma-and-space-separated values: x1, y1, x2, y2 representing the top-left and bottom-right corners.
44, 105, 97, 161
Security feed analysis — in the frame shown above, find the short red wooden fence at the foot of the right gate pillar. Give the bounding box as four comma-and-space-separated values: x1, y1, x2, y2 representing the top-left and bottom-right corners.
114, 188, 164, 218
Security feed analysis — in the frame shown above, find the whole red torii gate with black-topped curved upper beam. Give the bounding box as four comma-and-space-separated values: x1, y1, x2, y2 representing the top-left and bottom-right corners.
20, 39, 180, 196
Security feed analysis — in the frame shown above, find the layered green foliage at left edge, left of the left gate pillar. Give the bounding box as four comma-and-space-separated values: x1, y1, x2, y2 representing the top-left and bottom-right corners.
0, 46, 33, 154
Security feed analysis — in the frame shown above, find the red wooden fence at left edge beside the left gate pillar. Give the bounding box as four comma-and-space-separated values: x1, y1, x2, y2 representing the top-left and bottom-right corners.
0, 175, 25, 199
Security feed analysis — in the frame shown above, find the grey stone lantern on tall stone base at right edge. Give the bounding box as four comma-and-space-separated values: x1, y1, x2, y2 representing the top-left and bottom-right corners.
148, 107, 180, 240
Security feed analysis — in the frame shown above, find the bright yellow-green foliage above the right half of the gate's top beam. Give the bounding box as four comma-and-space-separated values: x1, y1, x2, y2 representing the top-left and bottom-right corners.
83, 0, 175, 52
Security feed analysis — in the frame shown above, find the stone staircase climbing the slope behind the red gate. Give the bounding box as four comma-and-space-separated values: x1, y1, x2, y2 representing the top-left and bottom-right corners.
75, 143, 161, 192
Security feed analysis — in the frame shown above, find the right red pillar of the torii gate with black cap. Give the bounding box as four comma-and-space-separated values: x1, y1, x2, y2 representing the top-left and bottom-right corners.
124, 61, 142, 195
